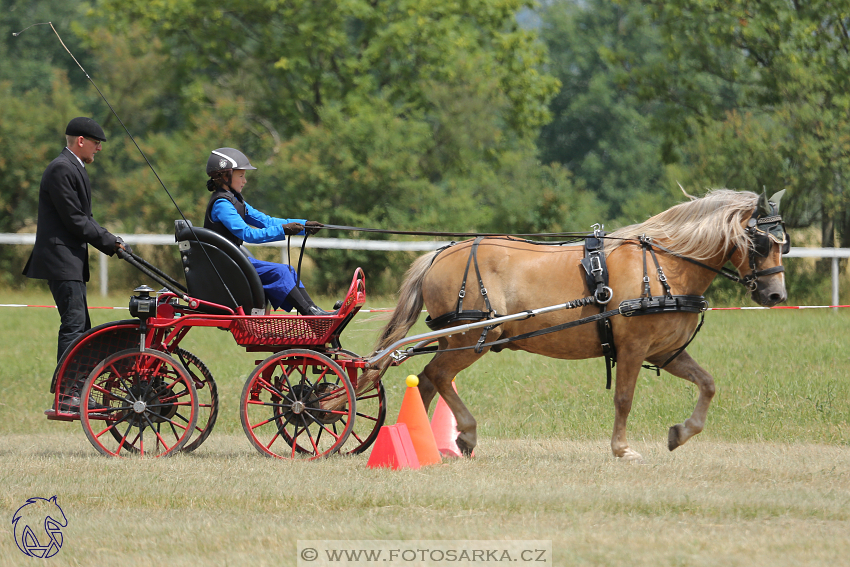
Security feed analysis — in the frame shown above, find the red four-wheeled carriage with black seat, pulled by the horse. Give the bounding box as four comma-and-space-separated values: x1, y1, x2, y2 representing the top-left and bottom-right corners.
45, 221, 386, 458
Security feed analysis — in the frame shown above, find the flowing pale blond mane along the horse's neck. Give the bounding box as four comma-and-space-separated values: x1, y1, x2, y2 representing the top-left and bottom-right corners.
606, 189, 758, 260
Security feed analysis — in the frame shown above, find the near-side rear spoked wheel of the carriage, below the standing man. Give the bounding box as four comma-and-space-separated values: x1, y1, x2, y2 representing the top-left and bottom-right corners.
80, 349, 198, 457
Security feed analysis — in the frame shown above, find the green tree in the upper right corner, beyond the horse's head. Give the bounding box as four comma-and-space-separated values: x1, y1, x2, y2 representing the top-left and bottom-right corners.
635, 0, 850, 246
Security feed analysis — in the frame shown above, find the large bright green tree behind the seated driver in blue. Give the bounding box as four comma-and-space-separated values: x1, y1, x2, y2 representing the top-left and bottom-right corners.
84, 0, 572, 288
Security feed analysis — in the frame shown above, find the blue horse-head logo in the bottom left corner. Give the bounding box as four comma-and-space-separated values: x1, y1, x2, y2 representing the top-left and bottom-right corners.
12, 496, 68, 559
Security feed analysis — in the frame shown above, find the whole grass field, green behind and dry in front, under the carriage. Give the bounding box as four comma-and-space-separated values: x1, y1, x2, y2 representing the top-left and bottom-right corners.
0, 292, 850, 566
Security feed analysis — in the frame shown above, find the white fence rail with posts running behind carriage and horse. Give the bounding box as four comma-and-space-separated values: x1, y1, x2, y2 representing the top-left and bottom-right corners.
0, 233, 850, 305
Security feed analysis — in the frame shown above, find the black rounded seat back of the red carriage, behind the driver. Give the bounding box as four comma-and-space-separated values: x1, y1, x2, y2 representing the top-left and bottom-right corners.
174, 220, 266, 315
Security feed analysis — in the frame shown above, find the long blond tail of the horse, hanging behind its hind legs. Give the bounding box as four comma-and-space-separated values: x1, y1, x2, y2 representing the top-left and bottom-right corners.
357, 250, 438, 393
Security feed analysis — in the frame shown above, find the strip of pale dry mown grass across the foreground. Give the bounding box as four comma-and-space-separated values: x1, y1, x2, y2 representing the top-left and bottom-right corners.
0, 434, 850, 566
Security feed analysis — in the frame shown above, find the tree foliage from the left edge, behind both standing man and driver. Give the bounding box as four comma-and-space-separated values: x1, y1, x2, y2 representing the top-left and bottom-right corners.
0, 0, 584, 289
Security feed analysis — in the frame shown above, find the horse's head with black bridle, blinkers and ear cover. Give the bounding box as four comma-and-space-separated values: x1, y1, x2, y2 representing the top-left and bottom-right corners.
733, 189, 791, 307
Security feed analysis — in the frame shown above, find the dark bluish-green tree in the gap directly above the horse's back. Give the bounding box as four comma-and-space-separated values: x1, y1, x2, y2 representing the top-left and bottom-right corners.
538, 0, 681, 225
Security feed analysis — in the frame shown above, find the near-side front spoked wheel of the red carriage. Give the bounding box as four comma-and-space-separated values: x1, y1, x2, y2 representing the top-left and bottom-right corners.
239, 350, 356, 459
